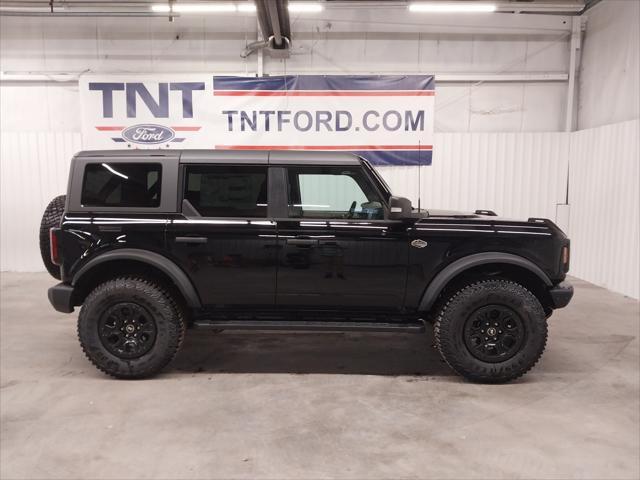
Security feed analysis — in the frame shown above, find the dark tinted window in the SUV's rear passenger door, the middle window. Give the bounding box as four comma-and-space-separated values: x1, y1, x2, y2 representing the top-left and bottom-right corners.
184, 165, 267, 217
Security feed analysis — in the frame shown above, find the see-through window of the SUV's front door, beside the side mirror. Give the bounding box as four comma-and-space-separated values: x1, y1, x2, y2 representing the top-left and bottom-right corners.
288, 167, 384, 220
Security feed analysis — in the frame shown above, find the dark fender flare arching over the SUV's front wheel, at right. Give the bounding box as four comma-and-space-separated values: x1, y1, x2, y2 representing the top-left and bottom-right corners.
419, 252, 552, 312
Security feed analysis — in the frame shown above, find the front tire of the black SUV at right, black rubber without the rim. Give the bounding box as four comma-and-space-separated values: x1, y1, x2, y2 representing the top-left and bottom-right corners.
434, 280, 547, 383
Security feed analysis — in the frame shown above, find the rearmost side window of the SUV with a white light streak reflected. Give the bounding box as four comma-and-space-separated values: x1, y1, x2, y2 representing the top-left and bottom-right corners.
81, 163, 162, 208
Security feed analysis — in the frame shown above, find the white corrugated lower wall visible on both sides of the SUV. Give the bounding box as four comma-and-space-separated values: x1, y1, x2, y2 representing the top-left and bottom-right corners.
0, 125, 640, 298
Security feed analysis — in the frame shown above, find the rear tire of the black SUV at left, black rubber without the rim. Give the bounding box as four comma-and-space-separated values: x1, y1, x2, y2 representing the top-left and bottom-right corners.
78, 277, 186, 379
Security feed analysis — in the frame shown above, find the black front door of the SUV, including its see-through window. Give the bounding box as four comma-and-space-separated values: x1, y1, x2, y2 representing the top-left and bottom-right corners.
276, 165, 408, 311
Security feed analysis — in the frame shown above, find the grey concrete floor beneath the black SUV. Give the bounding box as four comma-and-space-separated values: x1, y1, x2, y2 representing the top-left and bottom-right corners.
0, 274, 640, 479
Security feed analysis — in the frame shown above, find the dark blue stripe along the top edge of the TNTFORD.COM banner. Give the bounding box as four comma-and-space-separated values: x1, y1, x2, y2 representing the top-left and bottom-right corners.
213, 75, 435, 90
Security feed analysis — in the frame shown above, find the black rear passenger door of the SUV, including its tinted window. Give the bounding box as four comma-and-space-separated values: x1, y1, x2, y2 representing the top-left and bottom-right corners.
167, 161, 277, 309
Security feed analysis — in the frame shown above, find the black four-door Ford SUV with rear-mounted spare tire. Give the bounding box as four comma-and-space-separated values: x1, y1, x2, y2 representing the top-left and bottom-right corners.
41, 150, 573, 383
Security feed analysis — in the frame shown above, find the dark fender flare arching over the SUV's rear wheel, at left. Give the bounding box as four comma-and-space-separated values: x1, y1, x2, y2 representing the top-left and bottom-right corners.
71, 248, 202, 308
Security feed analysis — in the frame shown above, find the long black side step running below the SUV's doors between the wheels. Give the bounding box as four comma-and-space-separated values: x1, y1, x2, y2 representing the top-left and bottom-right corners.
193, 320, 425, 333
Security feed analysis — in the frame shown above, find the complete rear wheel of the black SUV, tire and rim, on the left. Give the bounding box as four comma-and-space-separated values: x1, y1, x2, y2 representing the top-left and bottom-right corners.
78, 277, 185, 378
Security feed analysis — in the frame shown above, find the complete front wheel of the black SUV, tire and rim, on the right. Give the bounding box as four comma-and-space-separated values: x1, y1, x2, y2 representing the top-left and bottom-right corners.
434, 280, 547, 383
